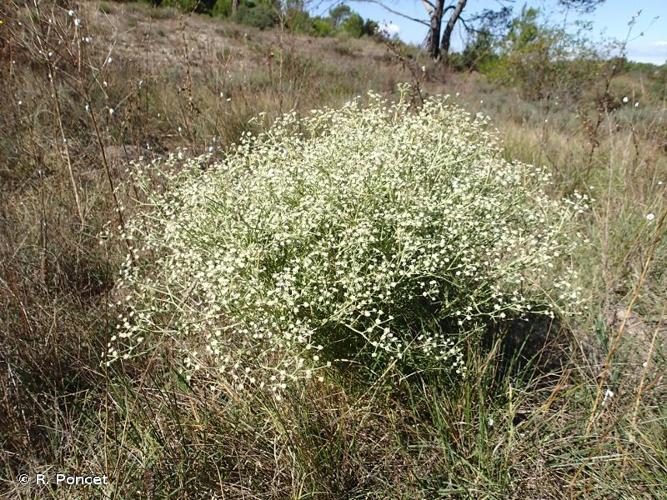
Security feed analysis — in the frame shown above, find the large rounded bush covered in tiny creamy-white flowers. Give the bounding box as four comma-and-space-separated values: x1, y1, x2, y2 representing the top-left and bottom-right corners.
109, 90, 585, 397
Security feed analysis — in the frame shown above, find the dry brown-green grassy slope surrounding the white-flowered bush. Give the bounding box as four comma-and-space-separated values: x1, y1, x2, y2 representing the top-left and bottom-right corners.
0, 2, 667, 498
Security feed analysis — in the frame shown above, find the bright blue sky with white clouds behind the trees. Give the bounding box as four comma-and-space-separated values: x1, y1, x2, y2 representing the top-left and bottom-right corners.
318, 0, 667, 64
